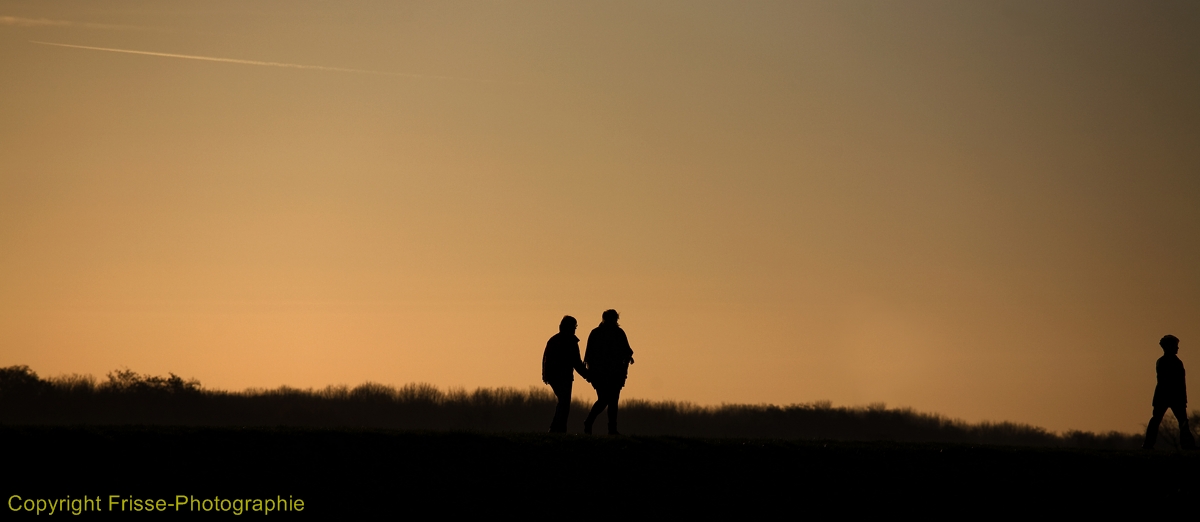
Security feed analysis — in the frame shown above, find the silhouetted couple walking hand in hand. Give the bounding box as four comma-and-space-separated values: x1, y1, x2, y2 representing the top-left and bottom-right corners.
541, 310, 634, 434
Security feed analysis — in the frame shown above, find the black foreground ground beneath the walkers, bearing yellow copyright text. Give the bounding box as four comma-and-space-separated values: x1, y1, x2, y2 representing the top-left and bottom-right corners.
0, 426, 1200, 520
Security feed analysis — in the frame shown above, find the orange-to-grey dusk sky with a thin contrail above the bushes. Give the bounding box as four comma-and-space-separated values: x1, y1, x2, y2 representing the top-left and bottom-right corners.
0, 0, 1200, 431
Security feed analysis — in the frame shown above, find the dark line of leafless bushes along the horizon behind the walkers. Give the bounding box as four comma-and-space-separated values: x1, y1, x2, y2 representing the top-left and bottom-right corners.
0, 366, 1161, 449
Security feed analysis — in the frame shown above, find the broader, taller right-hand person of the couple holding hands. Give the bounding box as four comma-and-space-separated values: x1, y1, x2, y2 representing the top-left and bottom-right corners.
583, 310, 634, 434
